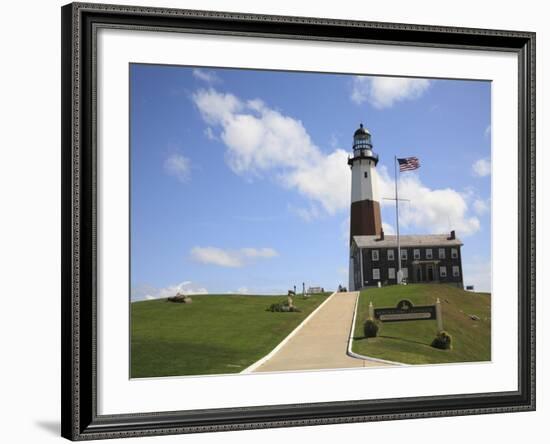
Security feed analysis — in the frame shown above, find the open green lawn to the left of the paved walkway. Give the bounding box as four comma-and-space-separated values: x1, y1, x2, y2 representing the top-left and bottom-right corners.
131, 293, 330, 378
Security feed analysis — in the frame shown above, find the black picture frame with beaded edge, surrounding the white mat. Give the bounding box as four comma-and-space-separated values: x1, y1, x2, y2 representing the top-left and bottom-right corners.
61, 3, 535, 440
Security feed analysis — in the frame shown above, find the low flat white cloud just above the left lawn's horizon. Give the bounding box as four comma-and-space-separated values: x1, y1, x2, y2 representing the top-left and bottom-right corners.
191, 247, 278, 268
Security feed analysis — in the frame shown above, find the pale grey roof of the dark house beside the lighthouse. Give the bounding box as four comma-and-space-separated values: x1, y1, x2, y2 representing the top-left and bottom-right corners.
353, 234, 463, 248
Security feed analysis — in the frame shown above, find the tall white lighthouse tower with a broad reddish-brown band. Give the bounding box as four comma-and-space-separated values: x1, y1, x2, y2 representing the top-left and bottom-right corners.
348, 124, 382, 291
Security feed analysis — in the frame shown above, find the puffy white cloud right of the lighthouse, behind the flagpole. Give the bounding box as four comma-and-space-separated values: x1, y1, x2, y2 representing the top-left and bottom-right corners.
379, 167, 480, 236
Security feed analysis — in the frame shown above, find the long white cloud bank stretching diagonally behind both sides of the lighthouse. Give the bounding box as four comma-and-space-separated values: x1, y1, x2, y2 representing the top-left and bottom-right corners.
193, 88, 480, 238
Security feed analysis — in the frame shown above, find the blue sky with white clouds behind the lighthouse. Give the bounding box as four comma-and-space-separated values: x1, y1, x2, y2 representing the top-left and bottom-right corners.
130, 64, 491, 300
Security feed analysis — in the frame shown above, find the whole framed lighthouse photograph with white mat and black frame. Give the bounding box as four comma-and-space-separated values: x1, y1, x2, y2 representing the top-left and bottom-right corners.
61, 3, 535, 440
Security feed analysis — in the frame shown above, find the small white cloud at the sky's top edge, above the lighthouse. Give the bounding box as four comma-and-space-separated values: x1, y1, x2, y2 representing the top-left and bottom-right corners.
351, 76, 430, 109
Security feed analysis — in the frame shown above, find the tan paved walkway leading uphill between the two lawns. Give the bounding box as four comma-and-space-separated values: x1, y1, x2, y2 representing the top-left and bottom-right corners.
254, 292, 394, 372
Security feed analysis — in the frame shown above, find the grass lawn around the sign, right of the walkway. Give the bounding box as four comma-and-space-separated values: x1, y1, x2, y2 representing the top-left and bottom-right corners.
352, 284, 491, 364
